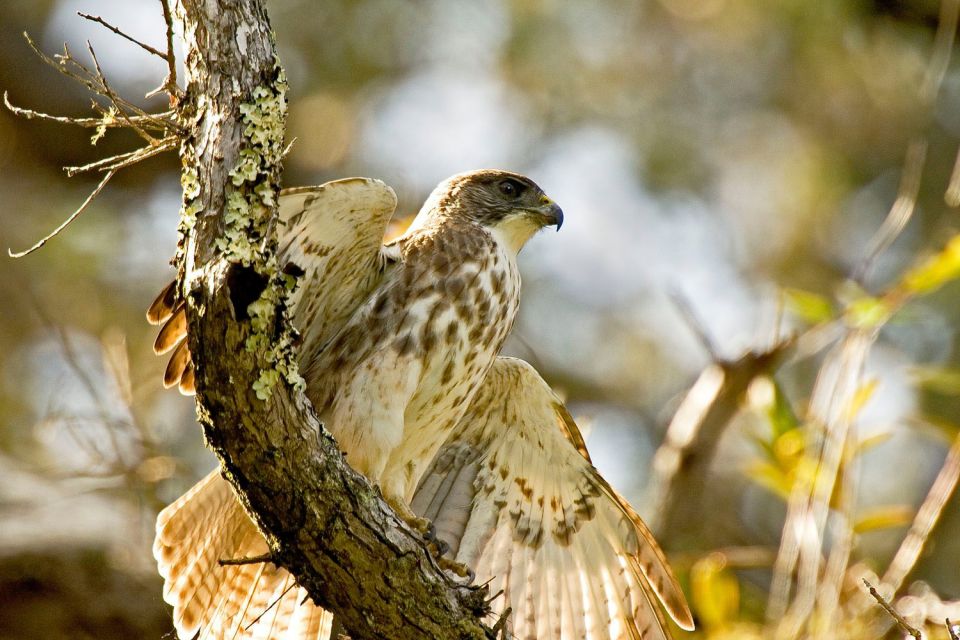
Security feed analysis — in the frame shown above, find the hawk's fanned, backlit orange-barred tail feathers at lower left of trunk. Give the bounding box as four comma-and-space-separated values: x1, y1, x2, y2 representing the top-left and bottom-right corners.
153, 471, 333, 640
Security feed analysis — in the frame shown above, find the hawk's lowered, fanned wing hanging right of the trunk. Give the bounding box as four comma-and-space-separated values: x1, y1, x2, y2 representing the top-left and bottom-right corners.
412, 358, 693, 640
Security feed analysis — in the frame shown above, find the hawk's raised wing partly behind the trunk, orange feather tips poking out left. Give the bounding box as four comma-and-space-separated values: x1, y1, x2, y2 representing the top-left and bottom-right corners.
147, 178, 397, 394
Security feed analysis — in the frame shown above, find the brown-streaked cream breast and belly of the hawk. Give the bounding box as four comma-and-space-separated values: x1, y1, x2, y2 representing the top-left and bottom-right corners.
307, 229, 520, 495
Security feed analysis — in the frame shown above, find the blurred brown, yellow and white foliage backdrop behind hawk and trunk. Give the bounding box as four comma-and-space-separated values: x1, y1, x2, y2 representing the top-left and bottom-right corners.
0, 0, 960, 638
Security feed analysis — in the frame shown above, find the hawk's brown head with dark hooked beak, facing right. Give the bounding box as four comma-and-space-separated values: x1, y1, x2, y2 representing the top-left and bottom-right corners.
418, 169, 563, 252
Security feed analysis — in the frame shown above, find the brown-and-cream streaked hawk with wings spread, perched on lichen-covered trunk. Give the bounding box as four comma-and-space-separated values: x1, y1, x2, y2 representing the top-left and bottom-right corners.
148, 170, 692, 640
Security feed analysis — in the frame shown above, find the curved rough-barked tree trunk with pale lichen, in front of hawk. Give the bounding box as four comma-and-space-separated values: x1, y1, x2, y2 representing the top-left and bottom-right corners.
171, 0, 491, 639
